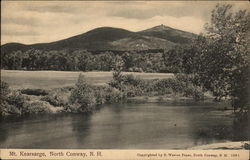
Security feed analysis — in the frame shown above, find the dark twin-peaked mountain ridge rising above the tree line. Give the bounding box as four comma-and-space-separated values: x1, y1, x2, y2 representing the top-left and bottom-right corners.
1, 25, 196, 53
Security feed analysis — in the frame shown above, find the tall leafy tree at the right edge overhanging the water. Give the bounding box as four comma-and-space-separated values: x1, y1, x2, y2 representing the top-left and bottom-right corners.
186, 4, 250, 113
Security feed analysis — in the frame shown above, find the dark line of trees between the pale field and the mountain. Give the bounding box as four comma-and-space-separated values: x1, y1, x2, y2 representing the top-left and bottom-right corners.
1, 49, 171, 72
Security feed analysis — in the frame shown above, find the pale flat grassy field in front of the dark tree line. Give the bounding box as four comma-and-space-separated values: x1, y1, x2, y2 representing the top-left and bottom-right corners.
1, 70, 173, 89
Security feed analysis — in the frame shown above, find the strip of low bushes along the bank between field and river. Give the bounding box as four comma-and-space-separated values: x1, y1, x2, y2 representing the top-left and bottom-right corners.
1, 71, 207, 116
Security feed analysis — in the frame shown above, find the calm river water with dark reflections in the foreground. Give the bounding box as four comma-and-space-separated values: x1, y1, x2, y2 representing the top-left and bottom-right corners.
0, 103, 247, 149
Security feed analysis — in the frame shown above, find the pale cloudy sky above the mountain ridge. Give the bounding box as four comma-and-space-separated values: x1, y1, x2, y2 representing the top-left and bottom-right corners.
1, 1, 249, 44
